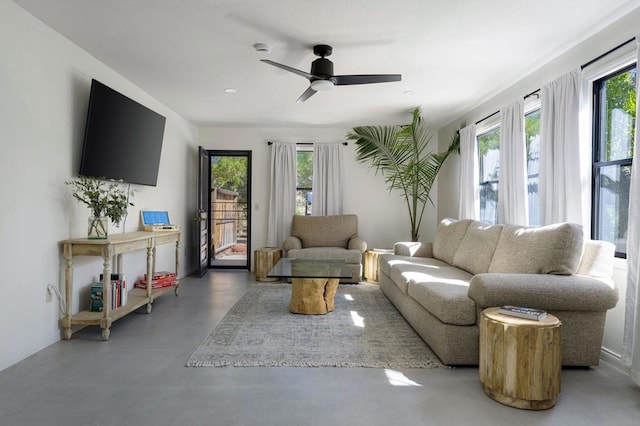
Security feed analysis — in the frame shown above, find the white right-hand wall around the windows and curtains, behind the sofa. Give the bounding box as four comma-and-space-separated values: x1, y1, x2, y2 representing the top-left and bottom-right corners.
437, 10, 640, 355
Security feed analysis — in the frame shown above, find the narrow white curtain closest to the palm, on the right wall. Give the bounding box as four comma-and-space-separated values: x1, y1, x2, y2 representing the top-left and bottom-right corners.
458, 124, 480, 219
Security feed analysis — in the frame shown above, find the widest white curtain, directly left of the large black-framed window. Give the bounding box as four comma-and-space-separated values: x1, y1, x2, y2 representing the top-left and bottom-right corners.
539, 70, 589, 225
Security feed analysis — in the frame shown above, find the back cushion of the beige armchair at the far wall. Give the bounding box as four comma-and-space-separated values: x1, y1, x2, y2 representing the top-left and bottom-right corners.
291, 214, 358, 249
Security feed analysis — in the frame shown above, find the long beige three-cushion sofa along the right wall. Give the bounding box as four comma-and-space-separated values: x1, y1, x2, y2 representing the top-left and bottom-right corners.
380, 219, 618, 366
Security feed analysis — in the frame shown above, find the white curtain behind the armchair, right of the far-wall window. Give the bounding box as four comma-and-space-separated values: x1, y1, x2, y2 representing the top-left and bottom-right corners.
311, 143, 343, 216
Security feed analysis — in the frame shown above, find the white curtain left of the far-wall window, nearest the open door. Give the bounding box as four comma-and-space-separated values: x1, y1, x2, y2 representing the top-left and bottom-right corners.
267, 142, 297, 247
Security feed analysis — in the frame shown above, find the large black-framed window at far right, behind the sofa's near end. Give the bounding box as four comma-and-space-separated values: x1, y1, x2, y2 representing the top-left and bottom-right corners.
591, 64, 637, 257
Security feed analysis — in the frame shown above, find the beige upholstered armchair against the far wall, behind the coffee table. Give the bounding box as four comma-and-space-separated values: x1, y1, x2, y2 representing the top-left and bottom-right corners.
282, 214, 367, 283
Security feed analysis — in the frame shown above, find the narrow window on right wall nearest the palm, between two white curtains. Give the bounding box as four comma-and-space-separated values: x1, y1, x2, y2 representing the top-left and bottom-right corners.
477, 127, 500, 223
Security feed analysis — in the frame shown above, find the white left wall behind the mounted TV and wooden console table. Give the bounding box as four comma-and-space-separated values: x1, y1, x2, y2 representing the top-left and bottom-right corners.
0, 0, 198, 370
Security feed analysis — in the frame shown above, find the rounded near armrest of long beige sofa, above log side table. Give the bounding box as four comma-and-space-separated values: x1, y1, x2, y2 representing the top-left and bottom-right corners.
468, 273, 618, 311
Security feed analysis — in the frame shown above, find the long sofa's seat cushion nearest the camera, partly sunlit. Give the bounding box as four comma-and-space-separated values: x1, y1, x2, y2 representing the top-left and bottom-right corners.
407, 266, 476, 325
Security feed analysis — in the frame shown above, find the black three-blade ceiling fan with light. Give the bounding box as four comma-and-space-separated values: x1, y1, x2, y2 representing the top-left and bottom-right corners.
261, 44, 402, 102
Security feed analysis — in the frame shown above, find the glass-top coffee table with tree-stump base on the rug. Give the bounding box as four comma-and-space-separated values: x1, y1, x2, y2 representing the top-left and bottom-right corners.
267, 258, 351, 315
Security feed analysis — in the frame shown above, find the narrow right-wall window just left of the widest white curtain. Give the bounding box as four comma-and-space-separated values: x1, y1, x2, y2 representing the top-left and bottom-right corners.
524, 108, 540, 226
